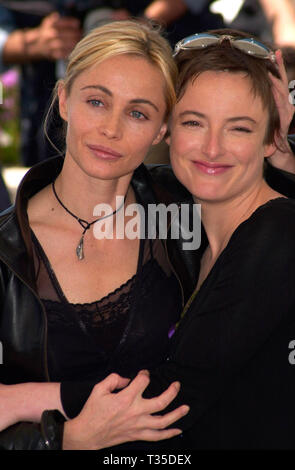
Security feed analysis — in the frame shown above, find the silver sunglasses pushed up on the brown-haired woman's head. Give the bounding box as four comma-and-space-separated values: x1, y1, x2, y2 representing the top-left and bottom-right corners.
173, 33, 276, 63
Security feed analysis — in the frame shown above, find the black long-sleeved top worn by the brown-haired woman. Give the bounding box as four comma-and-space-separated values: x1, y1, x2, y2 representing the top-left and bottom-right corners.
140, 198, 295, 449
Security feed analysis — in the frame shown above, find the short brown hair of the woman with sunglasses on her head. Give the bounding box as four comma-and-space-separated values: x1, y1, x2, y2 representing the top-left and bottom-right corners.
175, 28, 280, 144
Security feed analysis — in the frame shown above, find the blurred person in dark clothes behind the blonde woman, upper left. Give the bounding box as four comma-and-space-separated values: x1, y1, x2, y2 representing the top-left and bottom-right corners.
0, 0, 148, 167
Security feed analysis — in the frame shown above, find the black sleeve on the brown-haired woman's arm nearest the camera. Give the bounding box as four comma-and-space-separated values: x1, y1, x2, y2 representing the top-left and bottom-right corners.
145, 199, 295, 430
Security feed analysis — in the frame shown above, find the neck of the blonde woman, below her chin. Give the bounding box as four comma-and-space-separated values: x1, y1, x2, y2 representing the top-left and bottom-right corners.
53, 154, 134, 222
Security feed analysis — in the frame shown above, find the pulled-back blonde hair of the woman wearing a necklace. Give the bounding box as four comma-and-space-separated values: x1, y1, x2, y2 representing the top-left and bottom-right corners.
45, 20, 178, 151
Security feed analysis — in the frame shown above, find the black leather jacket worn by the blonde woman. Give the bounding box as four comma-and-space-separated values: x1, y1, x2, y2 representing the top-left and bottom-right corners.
0, 153, 196, 450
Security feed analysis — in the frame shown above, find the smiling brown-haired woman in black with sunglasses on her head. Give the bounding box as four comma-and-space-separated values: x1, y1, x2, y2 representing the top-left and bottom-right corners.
142, 30, 295, 449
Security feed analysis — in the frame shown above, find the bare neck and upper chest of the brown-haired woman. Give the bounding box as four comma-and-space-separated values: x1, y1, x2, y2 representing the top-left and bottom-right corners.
196, 181, 280, 262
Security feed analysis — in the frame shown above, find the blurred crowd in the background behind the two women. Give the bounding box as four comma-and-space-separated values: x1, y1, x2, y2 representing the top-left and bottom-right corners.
0, 0, 295, 209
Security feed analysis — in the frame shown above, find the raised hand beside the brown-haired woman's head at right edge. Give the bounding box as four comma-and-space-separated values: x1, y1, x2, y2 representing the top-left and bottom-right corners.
269, 50, 295, 173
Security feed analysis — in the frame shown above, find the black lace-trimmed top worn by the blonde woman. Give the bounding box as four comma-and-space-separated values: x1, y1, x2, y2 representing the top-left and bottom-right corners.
32, 232, 181, 382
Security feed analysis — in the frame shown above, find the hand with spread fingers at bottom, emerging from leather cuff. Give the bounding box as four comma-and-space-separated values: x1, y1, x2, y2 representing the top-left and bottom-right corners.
63, 371, 189, 450
